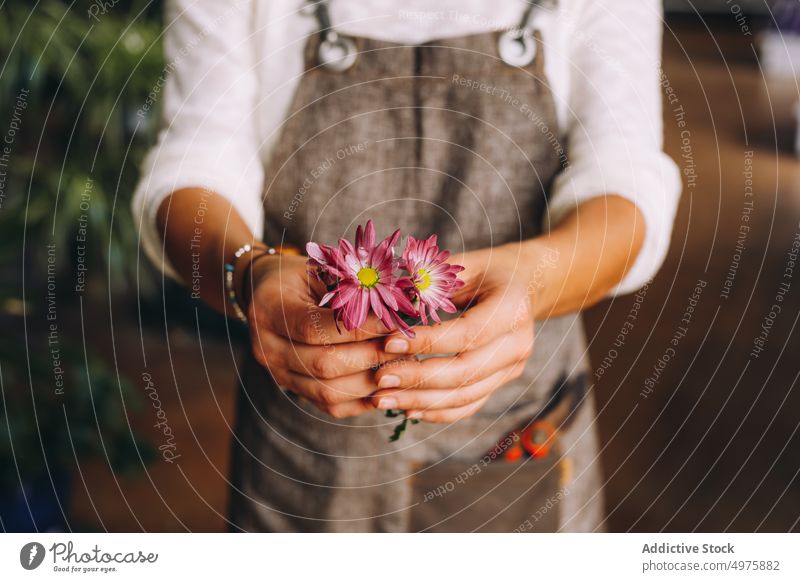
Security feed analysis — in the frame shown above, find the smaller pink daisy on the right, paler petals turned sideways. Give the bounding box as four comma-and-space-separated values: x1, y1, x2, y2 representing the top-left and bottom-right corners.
400, 234, 464, 325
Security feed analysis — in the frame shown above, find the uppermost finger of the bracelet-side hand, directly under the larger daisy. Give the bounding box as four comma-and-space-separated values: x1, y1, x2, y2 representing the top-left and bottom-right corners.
254, 292, 389, 346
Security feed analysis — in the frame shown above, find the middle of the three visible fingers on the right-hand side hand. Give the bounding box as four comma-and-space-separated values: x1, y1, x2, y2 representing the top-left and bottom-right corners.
375, 327, 533, 389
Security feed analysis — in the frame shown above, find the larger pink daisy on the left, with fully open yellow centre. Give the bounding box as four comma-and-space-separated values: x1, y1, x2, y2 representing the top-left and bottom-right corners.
306, 220, 417, 337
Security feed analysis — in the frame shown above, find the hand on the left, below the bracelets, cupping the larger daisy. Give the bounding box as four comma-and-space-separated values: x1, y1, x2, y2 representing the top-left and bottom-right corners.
248, 256, 398, 418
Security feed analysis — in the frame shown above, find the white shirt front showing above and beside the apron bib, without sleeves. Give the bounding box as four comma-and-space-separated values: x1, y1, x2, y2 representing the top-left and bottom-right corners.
248, 0, 581, 178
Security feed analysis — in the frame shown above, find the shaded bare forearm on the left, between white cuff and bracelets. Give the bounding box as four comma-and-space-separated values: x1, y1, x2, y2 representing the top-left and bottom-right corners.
156, 188, 254, 315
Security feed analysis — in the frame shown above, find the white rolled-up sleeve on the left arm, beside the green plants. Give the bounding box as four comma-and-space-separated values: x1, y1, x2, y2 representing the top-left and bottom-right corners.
133, 0, 264, 278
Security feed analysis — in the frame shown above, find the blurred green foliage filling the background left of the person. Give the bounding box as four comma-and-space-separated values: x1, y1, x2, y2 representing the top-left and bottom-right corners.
0, 0, 163, 530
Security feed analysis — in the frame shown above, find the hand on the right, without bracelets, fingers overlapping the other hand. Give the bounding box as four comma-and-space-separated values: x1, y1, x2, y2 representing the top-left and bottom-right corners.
372, 244, 553, 422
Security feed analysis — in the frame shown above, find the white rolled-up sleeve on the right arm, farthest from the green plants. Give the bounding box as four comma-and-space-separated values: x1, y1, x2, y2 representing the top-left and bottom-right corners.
548, 0, 682, 295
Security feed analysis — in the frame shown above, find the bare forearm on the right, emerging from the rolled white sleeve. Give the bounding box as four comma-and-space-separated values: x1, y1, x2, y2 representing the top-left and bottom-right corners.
523, 194, 645, 319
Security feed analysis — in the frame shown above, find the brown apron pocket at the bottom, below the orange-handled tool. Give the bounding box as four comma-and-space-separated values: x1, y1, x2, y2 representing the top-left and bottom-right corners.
411, 454, 568, 532
